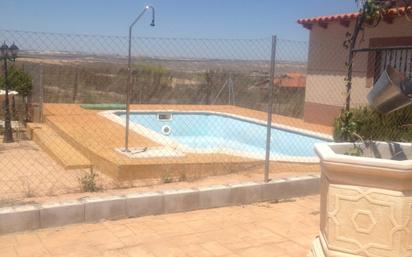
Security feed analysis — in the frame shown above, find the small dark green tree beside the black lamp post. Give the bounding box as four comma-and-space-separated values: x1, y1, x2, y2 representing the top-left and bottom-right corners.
0, 66, 33, 121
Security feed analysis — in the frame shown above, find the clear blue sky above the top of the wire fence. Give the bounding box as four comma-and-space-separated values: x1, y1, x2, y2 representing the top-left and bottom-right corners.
0, 0, 357, 41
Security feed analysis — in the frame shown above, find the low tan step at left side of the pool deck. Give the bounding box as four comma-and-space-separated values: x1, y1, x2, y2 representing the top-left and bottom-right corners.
27, 123, 92, 170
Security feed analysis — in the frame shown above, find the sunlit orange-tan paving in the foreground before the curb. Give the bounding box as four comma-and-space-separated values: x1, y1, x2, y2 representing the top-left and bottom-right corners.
0, 196, 319, 257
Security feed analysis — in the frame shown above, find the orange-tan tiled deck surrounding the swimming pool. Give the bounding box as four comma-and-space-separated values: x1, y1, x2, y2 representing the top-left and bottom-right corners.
37, 104, 332, 180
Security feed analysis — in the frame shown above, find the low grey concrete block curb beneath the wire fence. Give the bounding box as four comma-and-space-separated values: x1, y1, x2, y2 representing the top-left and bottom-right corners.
0, 175, 320, 234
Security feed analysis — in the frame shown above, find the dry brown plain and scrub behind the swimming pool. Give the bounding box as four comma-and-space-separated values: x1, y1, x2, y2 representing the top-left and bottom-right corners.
19, 52, 306, 117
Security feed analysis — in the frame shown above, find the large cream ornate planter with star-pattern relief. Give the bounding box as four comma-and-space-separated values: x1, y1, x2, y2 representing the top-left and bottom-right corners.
310, 142, 412, 257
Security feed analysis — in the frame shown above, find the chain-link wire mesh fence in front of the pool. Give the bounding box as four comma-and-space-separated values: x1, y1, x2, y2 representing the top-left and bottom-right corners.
0, 30, 367, 204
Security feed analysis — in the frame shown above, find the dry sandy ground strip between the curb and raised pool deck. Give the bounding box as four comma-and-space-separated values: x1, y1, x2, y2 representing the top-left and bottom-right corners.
0, 141, 319, 206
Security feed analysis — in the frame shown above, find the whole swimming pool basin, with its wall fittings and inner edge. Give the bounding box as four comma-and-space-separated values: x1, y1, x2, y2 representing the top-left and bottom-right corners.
104, 111, 329, 161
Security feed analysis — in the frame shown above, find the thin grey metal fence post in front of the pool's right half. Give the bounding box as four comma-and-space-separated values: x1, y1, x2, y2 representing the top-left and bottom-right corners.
264, 36, 277, 182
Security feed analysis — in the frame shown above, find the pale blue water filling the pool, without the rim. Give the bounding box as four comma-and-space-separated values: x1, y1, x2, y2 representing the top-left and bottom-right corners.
116, 112, 326, 157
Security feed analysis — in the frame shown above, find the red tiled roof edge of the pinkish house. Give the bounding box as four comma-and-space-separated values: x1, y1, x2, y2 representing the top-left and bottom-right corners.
298, 7, 412, 28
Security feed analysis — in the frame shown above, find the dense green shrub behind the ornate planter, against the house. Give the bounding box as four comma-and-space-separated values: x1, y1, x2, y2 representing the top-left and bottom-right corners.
333, 106, 412, 142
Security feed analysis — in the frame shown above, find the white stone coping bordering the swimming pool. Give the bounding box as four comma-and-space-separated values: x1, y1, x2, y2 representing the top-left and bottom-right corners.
98, 109, 333, 163
